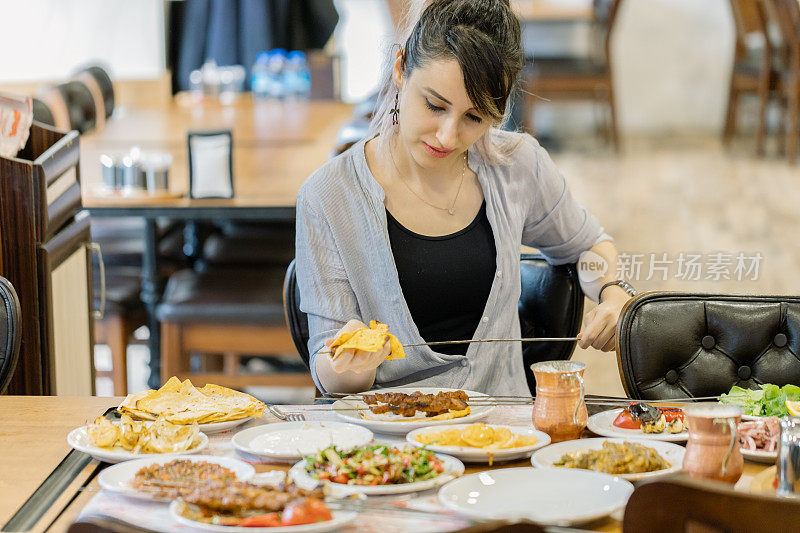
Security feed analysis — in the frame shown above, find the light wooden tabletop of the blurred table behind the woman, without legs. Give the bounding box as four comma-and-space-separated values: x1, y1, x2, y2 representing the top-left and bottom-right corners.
80, 94, 352, 209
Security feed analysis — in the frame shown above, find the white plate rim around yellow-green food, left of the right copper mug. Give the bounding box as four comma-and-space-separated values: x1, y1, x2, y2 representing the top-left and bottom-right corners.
531, 439, 686, 481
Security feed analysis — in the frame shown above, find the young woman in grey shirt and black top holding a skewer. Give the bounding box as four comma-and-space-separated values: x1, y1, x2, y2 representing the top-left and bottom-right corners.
296, 0, 629, 395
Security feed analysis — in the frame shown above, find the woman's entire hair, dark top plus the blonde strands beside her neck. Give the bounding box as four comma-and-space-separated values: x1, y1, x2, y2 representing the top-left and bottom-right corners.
368, 0, 524, 162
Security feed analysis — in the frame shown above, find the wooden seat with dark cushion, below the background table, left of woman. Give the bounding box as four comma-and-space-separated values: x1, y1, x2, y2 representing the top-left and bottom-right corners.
156, 267, 314, 388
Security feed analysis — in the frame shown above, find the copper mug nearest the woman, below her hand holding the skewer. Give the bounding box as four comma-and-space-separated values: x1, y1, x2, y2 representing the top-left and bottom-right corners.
531, 361, 588, 443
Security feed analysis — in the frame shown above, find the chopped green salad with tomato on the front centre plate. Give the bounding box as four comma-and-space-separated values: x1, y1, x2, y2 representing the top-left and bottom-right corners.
305, 444, 444, 485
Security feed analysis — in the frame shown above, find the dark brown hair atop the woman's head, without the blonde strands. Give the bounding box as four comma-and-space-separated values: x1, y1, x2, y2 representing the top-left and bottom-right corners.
401, 0, 523, 123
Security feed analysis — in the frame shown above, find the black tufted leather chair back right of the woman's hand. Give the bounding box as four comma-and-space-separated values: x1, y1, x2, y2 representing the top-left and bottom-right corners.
617, 292, 800, 400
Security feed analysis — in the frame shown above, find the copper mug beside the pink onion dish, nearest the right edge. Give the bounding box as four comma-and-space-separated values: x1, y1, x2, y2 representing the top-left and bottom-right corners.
683, 405, 744, 484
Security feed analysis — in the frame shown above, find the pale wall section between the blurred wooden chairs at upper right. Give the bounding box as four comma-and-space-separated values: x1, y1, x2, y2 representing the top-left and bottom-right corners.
613, 0, 735, 133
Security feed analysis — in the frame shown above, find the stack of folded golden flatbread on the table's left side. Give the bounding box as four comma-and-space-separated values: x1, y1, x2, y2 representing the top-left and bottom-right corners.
117, 376, 266, 424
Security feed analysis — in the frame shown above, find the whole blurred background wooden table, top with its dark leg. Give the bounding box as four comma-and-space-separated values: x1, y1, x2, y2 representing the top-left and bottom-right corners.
80, 93, 353, 388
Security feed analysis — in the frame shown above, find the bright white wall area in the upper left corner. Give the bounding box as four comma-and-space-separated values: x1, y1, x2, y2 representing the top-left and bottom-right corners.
0, 0, 166, 83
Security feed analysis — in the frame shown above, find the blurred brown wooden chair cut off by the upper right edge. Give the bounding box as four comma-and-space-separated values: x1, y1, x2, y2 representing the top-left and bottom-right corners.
769, 0, 800, 163
